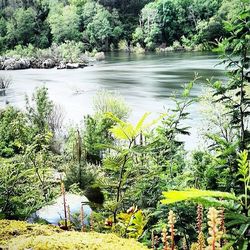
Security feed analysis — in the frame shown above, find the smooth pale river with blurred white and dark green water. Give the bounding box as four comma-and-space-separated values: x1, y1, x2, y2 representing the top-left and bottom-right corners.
0, 52, 226, 148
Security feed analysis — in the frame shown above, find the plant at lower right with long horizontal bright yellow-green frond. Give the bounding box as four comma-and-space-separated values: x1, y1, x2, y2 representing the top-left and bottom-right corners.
161, 151, 250, 249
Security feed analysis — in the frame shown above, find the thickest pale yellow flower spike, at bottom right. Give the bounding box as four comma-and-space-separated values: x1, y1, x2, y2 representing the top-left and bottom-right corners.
206, 207, 223, 250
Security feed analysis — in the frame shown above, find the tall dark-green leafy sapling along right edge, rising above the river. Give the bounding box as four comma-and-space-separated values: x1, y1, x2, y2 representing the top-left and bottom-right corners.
210, 6, 250, 150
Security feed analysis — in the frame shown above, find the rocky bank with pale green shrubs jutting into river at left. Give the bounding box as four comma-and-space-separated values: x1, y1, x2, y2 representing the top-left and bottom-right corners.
0, 42, 105, 70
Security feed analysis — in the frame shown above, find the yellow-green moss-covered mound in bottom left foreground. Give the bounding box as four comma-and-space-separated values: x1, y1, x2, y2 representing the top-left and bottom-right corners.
0, 220, 147, 250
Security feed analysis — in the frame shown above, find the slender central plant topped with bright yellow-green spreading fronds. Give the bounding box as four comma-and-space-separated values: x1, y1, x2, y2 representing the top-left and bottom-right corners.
103, 113, 157, 223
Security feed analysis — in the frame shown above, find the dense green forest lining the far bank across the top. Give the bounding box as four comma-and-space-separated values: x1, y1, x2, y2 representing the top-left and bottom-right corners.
0, 0, 247, 52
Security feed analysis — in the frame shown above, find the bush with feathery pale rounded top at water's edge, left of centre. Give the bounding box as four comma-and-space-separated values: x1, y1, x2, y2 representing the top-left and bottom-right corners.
78, 90, 130, 164
